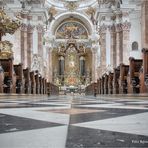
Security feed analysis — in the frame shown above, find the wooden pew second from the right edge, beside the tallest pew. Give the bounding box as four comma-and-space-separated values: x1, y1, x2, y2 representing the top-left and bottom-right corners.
128, 57, 142, 93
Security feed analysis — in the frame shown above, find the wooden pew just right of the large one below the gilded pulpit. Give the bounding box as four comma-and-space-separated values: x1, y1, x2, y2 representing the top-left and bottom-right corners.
14, 64, 24, 94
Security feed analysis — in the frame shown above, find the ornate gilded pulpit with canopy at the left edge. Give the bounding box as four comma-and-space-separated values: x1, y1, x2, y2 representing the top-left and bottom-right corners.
0, 8, 20, 59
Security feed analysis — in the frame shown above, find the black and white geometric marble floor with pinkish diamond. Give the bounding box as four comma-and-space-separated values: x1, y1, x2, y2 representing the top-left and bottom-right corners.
0, 95, 148, 148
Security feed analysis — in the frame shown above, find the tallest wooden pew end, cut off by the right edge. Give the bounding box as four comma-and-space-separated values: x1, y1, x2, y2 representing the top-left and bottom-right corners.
139, 48, 148, 93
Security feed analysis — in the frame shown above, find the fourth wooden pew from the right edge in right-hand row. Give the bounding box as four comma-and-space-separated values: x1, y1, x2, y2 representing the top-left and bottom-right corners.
113, 66, 120, 94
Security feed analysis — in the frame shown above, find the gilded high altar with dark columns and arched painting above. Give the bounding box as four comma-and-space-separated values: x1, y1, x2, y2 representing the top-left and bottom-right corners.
52, 20, 92, 88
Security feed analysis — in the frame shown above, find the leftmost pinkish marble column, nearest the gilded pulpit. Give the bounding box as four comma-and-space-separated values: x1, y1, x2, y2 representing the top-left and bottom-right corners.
21, 23, 27, 69
